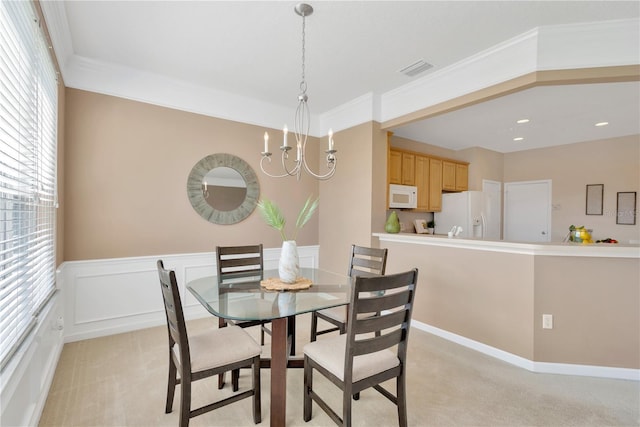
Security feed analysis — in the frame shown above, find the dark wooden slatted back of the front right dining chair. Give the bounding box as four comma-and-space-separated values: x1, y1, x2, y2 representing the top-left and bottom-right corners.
345, 269, 418, 362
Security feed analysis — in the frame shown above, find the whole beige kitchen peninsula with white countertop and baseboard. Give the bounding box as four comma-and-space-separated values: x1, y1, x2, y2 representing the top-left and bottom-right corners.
373, 233, 640, 380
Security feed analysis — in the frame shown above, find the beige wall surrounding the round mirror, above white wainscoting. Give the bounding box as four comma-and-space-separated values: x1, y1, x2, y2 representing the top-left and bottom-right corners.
64, 89, 320, 261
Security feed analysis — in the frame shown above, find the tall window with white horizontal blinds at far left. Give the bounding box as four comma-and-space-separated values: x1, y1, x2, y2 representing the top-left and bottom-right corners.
0, 1, 58, 369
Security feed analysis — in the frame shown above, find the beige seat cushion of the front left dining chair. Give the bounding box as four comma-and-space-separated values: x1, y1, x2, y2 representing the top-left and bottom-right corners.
173, 326, 261, 372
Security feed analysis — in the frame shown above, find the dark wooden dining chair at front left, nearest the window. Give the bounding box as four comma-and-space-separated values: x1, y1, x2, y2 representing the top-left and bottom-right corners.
157, 260, 262, 427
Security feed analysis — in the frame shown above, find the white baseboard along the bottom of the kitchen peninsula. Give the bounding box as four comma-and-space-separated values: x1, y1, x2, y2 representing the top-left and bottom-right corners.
411, 320, 640, 381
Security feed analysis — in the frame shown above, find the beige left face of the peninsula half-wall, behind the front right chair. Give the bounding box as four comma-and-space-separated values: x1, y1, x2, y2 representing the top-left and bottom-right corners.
382, 242, 534, 360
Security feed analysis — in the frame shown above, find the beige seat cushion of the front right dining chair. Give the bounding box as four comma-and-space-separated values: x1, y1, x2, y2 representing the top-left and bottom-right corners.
304, 335, 400, 382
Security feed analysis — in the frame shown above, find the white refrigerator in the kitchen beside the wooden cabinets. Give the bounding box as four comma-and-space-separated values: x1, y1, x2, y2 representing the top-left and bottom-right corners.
433, 191, 500, 240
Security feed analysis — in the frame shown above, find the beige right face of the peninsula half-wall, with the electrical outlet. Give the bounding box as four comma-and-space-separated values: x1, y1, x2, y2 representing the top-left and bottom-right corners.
535, 256, 640, 369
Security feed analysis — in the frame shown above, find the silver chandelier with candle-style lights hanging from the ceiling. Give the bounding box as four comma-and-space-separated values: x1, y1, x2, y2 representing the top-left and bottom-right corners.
260, 3, 337, 180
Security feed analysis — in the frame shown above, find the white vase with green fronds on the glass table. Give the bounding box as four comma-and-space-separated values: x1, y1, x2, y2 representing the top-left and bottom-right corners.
258, 196, 319, 284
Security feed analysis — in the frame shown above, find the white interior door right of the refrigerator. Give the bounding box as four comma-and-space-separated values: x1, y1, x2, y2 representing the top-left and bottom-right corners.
504, 180, 551, 242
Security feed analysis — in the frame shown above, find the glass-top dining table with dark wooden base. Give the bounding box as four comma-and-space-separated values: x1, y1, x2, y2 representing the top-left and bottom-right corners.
187, 268, 352, 427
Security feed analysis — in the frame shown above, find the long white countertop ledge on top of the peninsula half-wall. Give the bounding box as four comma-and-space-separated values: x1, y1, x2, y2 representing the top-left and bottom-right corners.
372, 233, 640, 259
